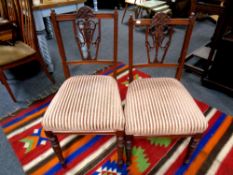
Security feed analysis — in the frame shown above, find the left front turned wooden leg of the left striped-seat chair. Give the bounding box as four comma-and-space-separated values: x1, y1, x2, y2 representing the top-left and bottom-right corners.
45, 131, 66, 168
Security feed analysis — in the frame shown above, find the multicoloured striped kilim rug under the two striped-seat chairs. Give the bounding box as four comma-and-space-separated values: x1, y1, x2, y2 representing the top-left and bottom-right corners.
0, 64, 233, 175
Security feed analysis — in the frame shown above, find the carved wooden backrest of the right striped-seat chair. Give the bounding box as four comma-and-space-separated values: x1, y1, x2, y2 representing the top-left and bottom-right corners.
128, 13, 195, 81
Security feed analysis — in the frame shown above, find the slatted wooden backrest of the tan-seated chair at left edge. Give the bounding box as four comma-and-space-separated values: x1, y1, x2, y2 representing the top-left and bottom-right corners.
15, 0, 39, 51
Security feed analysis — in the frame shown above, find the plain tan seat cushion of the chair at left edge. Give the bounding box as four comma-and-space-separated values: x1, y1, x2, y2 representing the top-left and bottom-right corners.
0, 41, 36, 66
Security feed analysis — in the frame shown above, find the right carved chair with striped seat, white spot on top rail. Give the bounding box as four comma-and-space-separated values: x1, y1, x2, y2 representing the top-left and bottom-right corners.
124, 13, 207, 164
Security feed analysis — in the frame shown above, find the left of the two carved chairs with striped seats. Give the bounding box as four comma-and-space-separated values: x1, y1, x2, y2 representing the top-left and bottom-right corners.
42, 7, 125, 166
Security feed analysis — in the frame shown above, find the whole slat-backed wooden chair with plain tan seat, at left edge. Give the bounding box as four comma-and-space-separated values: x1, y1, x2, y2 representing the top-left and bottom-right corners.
0, 0, 54, 102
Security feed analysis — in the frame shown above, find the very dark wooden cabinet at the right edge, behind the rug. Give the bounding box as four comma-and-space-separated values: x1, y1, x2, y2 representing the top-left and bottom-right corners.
202, 0, 233, 96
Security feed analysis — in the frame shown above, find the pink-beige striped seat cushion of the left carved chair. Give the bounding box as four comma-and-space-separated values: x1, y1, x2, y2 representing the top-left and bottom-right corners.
42, 75, 125, 132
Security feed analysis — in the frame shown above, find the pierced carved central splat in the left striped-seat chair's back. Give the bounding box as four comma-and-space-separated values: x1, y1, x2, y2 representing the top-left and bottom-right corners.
74, 7, 101, 60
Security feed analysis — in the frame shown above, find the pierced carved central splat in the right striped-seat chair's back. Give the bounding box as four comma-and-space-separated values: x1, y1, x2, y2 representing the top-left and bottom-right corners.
145, 13, 174, 63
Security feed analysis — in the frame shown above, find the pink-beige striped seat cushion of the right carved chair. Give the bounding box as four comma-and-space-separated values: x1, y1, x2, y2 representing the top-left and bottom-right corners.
125, 78, 207, 136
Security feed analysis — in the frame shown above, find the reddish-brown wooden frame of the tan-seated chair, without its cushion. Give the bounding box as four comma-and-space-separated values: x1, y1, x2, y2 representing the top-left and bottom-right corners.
0, 0, 55, 102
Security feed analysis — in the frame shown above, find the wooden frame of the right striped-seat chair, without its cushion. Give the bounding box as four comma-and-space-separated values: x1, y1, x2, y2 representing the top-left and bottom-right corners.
125, 13, 202, 165
